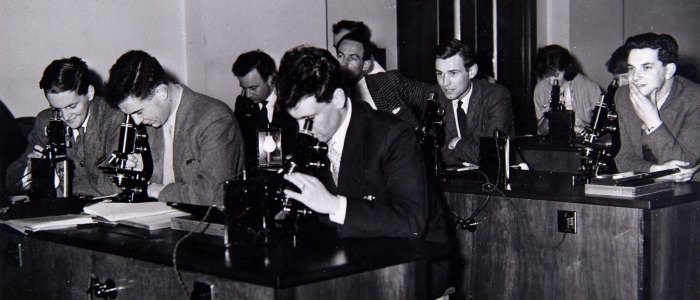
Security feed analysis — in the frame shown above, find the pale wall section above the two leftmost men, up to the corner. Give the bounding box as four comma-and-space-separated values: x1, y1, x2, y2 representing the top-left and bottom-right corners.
0, 0, 185, 117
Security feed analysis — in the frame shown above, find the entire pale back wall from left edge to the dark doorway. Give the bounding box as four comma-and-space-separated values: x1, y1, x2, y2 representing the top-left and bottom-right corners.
0, 0, 386, 117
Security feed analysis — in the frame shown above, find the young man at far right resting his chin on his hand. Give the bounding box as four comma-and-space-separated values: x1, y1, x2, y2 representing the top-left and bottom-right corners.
615, 33, 700, 182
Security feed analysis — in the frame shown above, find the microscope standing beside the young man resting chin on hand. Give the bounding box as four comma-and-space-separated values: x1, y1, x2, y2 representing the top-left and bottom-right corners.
580, 79, 620, 177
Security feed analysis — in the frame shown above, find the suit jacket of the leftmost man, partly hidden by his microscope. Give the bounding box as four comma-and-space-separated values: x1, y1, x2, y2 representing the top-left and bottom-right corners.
6, 97, 124, 196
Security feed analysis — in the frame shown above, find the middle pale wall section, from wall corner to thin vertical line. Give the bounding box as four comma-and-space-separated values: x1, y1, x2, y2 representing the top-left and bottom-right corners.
185, 0, 327, 107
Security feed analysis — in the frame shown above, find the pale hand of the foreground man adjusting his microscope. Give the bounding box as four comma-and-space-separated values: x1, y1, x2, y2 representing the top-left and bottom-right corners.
284, 173, 340, 214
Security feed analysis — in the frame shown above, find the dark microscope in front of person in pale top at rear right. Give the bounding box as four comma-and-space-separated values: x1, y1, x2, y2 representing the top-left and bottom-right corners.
545, 79, 576, 144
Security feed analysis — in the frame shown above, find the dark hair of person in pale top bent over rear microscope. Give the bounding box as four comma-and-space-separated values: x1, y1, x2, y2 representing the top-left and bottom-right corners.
535, 45, 579, 81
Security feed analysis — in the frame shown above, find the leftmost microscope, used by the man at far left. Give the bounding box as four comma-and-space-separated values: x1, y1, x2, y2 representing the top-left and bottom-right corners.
28, 109, 73, 200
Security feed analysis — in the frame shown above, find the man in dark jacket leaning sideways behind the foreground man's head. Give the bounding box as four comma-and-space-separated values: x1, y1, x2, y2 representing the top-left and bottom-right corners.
336, 30, 436, 129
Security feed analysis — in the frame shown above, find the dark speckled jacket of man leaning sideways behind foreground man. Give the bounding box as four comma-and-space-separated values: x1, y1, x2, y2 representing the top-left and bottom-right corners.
365, 71, 436, 129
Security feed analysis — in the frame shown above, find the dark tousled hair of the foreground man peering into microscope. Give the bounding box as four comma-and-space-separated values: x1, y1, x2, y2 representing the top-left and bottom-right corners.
275, 46, 347, 110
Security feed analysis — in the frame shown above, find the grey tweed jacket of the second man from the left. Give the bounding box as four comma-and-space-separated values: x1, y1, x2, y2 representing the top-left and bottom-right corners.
147, 85, 245, 207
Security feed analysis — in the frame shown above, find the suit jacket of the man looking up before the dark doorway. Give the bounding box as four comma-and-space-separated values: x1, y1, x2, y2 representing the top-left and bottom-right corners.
440, 80, 513, 165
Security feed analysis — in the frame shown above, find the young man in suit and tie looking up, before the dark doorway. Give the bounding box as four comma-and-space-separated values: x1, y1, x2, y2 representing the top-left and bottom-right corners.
434, 40, 513, 164
